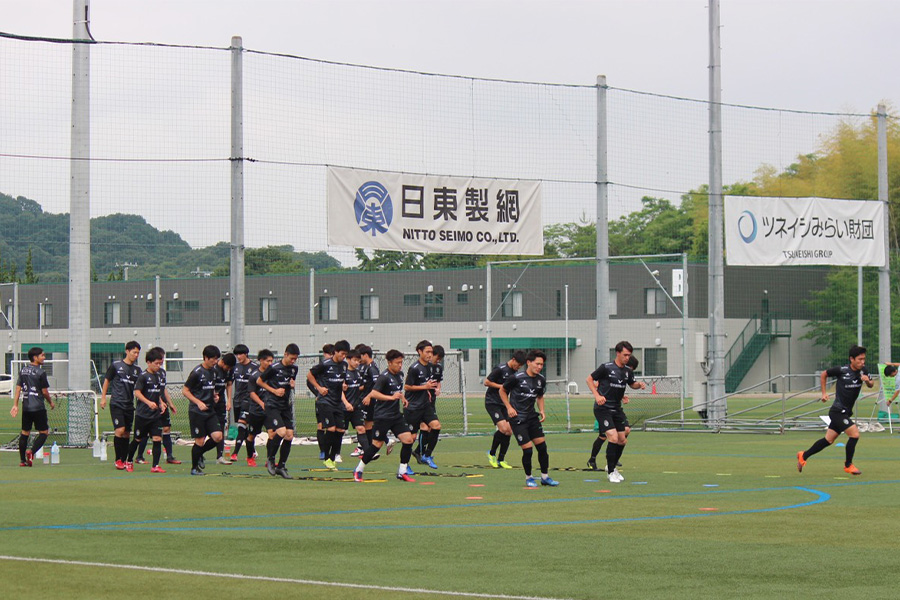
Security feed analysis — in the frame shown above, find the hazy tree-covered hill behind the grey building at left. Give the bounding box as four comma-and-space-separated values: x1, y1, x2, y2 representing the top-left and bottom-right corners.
0, 193, 340, 282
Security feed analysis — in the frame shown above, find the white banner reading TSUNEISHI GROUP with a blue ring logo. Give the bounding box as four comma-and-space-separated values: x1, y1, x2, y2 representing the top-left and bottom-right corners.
725, 196, 885, 267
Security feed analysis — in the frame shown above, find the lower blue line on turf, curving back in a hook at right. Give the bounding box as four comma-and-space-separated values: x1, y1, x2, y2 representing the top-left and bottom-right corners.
12, 486, 831, 532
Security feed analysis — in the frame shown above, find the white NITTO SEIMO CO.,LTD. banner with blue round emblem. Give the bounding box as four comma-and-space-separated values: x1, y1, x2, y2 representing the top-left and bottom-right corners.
328, 167, 544, 255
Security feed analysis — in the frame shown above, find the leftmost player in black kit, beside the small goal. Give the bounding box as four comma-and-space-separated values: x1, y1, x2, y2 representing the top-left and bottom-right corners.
9, 346, 56, 467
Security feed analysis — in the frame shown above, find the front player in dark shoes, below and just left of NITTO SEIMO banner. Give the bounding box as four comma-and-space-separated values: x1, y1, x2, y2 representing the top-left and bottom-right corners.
256, 344, 300, 479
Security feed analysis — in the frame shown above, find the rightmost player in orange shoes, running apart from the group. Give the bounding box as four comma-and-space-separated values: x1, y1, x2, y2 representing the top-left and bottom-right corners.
797, 346, 875, 475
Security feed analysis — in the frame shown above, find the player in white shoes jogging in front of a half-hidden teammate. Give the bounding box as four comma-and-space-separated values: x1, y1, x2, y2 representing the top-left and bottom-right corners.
587, 341, 647, 483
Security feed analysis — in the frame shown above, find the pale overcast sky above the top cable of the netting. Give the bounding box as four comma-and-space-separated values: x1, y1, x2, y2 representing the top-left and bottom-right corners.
0, 0, 900, 112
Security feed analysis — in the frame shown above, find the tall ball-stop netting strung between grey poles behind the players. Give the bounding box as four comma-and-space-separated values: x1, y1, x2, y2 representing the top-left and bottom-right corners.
0, 30, 900, 431
